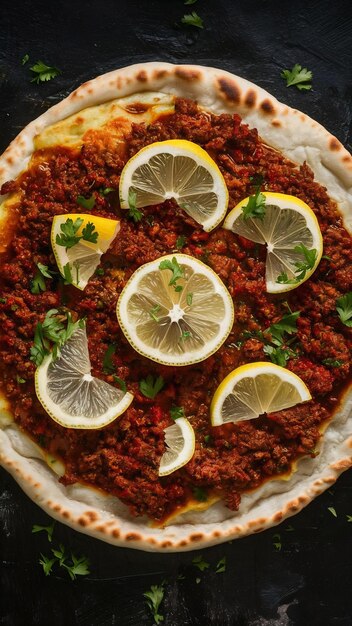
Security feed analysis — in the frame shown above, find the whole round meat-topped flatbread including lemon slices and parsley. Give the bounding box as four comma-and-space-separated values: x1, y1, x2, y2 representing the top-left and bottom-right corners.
0, 63, 352, 551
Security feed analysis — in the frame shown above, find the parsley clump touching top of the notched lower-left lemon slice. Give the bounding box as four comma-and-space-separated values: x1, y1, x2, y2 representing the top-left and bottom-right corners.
30, 309, 85, 367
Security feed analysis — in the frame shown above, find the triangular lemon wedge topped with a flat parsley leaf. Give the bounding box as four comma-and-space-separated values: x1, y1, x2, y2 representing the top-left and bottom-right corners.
51, 213, 120, 290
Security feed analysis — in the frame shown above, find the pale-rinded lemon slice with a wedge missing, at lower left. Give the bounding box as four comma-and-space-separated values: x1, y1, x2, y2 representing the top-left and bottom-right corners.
35, 328, 133, 428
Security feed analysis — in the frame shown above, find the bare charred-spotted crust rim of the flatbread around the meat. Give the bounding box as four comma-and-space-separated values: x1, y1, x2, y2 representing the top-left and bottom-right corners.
0, 62, 352, 551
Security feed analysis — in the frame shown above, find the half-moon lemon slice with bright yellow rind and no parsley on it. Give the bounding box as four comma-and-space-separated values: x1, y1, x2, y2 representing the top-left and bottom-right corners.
210, 362, 312, 426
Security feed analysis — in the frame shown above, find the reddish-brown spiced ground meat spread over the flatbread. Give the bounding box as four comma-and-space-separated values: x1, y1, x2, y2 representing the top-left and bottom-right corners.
0, 99, 352, 520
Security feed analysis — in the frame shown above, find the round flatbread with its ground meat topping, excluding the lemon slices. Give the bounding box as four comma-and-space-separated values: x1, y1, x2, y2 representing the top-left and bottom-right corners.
0, 62, 352, 551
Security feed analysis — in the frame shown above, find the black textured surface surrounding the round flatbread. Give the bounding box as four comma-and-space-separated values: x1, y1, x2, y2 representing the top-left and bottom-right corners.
0, 0, 352, 626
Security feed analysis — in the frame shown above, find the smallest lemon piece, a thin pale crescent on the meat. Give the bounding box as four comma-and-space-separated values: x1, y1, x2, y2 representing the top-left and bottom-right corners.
159, 417, 196, 476
